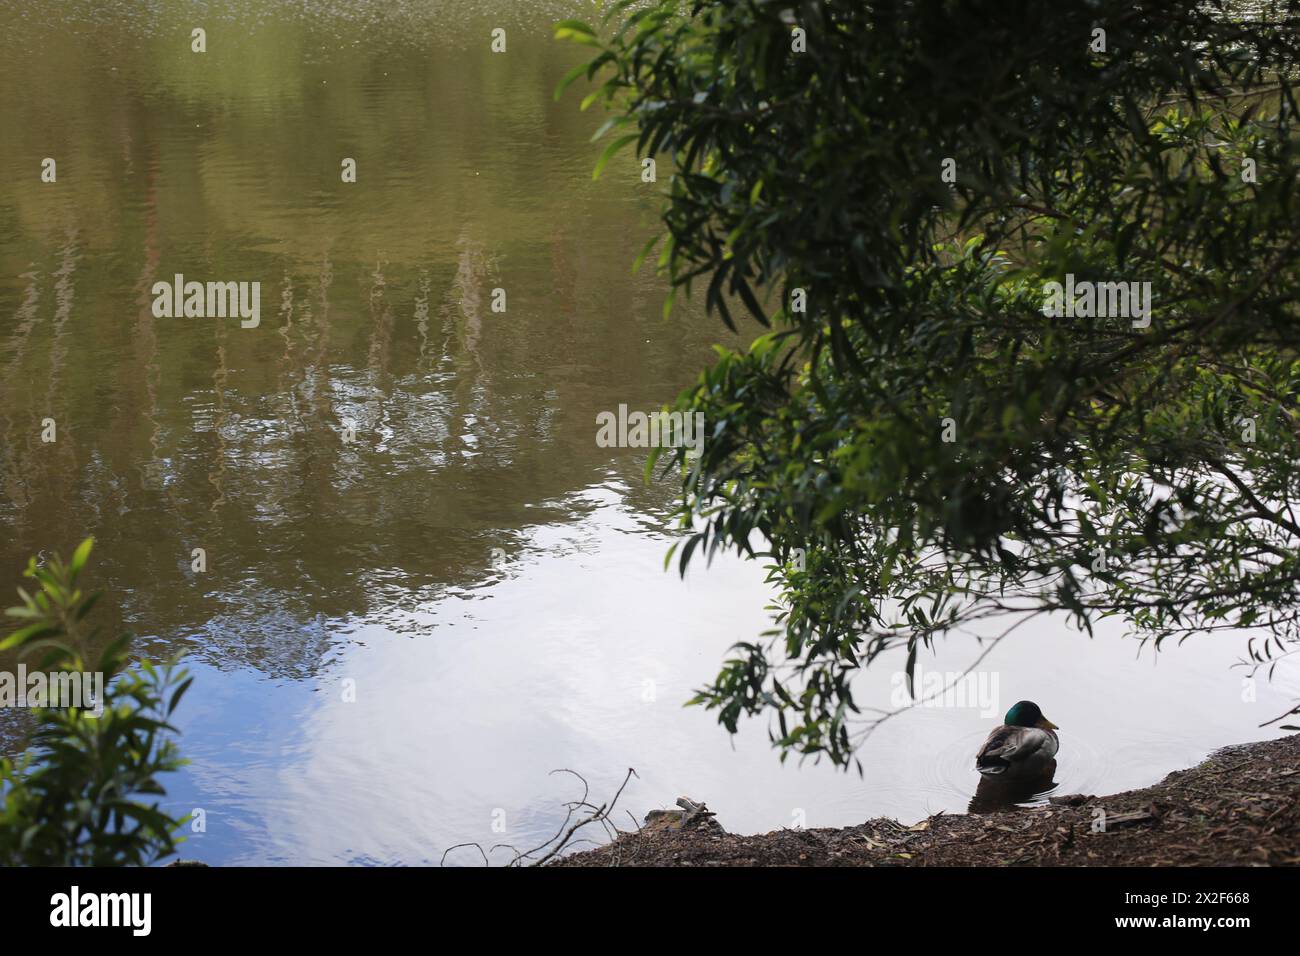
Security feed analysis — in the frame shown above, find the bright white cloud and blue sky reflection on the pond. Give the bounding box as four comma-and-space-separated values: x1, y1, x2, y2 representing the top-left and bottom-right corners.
159, 483, 1300, 865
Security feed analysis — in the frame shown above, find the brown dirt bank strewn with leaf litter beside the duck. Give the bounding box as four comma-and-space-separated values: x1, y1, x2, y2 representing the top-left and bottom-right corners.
553, 734, 1300, 866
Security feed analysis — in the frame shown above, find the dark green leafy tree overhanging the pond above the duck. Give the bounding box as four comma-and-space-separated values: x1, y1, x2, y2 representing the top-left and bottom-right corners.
558, 0, 1300, 762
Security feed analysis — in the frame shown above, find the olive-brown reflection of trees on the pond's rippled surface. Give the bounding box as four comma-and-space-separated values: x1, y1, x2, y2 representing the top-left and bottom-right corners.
0, 14, 748, 676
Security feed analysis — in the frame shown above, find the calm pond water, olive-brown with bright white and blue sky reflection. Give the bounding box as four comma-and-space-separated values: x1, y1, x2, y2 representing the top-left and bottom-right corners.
0, 0, 1300, 864
